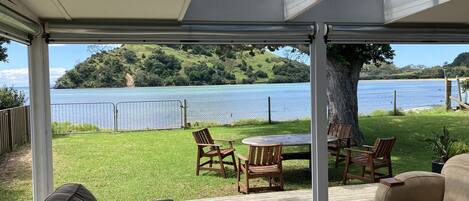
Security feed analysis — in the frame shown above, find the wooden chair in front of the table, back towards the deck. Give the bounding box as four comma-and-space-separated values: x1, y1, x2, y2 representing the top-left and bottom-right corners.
236, 145, 284, 194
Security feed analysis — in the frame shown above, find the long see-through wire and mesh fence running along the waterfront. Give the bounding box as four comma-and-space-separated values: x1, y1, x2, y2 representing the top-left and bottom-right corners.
52, 87, 462, 134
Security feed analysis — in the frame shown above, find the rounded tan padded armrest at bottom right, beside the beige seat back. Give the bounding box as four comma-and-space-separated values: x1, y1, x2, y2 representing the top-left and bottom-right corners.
375, 171, 445, 201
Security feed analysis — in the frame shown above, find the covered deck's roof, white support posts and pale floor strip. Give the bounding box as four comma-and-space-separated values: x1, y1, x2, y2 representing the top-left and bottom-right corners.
0, 0, 469, 201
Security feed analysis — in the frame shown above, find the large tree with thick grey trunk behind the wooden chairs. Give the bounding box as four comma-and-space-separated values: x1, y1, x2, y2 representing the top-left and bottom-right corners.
229, 44, 394, 144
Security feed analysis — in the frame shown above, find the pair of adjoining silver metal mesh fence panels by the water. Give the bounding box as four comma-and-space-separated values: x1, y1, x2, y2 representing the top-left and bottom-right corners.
51, 100, 183, 134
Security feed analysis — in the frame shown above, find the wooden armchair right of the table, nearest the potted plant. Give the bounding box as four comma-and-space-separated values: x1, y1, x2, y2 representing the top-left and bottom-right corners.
343, 137, 396, 184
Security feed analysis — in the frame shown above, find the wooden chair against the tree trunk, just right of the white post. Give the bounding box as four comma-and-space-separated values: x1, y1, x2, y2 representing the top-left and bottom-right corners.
327, 123, 352, 167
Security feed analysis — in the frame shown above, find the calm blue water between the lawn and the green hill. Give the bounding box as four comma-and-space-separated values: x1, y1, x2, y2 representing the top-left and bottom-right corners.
16, 80, 457, 129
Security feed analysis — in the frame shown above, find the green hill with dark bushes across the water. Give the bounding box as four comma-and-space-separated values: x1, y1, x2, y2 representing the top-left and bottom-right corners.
55, 44, 309, 88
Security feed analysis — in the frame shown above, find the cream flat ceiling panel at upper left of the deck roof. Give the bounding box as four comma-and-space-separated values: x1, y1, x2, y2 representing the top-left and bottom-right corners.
20, 0, 190, 20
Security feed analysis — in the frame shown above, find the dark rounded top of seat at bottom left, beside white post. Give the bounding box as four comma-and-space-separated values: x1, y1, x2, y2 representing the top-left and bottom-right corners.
44, 183, 96, 201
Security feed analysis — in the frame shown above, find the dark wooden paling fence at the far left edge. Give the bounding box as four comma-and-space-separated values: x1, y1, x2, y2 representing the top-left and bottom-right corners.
0, 106, 30, 155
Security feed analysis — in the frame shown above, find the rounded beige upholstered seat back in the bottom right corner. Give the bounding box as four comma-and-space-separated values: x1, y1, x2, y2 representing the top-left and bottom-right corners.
441, 154, 469, 201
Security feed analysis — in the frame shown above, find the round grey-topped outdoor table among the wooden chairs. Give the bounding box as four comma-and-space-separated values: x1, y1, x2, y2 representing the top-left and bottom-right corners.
241, 133, 337, 165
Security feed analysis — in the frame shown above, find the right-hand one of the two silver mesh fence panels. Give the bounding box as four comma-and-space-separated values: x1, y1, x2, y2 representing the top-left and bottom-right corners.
116, 100, 183, 131
